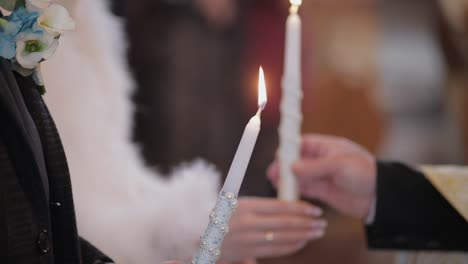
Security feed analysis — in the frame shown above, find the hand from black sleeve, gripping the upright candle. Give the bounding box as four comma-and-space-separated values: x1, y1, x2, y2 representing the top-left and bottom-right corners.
268, 135, 377, 219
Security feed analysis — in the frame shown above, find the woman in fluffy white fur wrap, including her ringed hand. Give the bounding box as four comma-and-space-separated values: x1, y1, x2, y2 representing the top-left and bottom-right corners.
42, 0, 326, 264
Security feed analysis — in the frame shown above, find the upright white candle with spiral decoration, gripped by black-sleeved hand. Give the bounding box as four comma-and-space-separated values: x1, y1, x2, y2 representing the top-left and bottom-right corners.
278, 0, 302, 201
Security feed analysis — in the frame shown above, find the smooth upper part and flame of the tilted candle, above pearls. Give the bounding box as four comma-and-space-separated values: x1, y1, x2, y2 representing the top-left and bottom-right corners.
222, 67, 267, 195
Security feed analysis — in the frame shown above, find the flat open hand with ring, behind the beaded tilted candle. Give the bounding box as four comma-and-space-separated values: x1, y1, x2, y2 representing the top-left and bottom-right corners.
221, 198, 327, 261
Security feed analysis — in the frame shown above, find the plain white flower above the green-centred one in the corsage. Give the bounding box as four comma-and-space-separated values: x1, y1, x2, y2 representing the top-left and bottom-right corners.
37, 3, 75, 36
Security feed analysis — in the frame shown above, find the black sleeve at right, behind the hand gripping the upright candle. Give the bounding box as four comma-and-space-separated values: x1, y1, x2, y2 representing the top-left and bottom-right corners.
366, 162, 468, 251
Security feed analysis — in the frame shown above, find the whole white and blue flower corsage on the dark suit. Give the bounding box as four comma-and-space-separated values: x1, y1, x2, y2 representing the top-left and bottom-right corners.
0, 0, 75, 94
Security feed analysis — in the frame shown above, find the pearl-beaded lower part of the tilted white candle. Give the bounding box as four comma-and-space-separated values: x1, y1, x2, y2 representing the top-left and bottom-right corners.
192, 191, 237, 264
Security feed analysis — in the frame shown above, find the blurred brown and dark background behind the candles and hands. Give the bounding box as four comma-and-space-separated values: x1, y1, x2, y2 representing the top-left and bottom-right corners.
114, 0, 468, 264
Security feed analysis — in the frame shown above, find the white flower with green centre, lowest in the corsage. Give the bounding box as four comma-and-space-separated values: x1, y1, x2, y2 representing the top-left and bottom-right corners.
16, 32, 58, 69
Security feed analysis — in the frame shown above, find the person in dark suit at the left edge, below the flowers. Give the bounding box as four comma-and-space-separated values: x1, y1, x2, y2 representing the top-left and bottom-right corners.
0, 58, 111, 264
